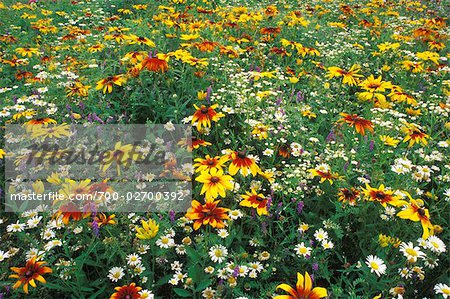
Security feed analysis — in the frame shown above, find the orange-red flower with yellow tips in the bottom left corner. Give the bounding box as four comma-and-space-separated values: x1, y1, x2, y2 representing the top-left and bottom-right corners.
9, 257, 52, 294
